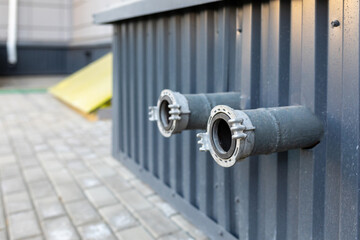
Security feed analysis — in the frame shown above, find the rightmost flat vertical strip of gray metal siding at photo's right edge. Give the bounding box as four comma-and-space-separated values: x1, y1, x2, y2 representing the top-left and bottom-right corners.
339, 0, 360, 239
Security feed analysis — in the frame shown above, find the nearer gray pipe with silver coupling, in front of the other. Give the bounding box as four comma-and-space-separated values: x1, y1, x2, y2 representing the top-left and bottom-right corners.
197, 105, 324, 167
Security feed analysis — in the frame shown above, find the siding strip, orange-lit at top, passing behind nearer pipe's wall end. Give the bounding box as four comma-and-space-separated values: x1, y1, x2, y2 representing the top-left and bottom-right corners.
298, 0, 315, 239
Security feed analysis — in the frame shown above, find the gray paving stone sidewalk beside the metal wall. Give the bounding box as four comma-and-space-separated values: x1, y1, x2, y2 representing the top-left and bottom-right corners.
0, 94, 206, 240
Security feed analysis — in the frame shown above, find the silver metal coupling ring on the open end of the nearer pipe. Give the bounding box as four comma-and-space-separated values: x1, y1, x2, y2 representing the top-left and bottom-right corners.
198, 105, 255, 167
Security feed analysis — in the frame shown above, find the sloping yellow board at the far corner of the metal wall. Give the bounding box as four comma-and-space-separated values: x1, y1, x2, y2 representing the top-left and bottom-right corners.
49, 53, 112, 113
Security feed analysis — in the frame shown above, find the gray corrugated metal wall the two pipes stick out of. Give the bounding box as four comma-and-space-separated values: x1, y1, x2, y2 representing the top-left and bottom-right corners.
113, 0, 360, 240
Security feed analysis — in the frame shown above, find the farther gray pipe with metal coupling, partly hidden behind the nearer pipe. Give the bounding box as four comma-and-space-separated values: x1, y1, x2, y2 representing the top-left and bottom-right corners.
149, 89, 240, 137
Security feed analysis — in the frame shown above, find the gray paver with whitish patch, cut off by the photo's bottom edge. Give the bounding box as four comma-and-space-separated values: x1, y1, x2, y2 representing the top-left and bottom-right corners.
79, 222, 116, 240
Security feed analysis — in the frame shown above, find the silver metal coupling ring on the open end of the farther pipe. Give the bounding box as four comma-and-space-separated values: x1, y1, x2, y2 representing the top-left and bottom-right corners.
149, 89, 190, 137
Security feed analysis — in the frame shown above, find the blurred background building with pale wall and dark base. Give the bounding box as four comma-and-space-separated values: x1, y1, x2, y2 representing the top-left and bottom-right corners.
0, 0, 122, 76
